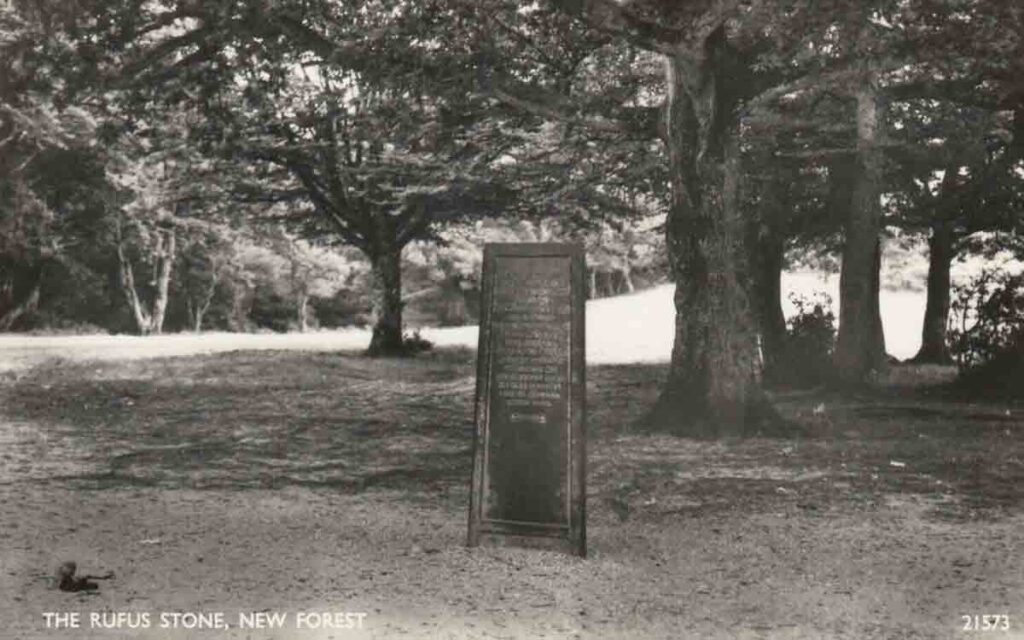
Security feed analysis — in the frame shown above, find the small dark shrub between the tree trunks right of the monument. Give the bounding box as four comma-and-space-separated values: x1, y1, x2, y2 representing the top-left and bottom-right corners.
771, 293, 836, 387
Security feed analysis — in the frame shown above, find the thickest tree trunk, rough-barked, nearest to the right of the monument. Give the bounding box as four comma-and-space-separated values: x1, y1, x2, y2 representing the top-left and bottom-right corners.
648, 43, 777, 436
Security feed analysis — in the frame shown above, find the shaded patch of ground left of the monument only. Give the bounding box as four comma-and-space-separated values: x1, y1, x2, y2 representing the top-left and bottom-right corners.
3, 352, 473, 489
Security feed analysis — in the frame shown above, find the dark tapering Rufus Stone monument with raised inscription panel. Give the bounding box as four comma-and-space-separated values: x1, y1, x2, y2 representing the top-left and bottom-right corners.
469, 244, 585, 555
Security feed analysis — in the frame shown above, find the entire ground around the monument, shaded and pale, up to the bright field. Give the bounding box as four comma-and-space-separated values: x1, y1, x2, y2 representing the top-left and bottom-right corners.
0, 337, 1024, 640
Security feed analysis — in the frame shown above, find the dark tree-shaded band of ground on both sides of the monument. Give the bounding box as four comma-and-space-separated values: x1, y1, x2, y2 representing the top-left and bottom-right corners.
0, 349, 1024, 522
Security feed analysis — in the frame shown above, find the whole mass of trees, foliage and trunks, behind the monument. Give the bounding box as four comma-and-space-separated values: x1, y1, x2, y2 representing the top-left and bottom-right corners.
0, 0, 1024, 435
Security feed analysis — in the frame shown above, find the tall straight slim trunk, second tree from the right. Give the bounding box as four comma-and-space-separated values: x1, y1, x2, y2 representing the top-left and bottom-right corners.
834, 79, 886, 384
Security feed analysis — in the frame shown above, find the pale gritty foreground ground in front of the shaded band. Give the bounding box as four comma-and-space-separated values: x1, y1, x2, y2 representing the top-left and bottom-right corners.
8, 484, 1024, 640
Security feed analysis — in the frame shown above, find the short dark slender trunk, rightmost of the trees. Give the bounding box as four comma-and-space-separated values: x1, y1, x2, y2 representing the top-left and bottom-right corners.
913, 220, 954, 365
